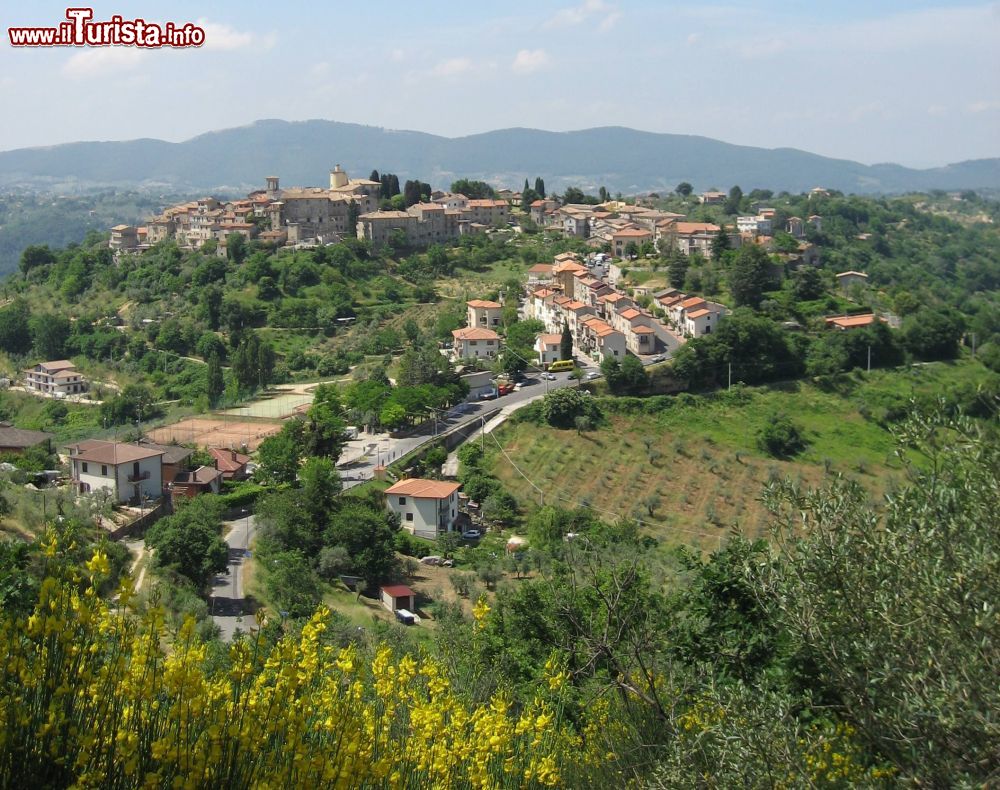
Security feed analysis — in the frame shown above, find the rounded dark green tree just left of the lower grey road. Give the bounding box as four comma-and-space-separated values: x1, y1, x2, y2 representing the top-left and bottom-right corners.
146, 496, 229, 592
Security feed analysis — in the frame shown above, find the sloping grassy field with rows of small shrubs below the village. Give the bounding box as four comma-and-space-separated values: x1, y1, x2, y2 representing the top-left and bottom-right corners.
482, 362, 991, 550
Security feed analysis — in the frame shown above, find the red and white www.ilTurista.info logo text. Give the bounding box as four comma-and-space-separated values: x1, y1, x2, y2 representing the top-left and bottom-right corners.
7, 8, 205, 47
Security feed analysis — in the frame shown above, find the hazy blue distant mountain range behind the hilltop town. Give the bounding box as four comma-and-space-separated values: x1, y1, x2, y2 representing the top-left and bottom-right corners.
0, 120, 1000, 194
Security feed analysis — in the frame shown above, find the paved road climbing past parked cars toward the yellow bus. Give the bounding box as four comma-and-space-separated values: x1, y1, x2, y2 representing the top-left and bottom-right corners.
339, 373, 574, 488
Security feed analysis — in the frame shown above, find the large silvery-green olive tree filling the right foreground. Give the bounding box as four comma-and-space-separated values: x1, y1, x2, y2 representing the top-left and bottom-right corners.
756, 408, 1000, 787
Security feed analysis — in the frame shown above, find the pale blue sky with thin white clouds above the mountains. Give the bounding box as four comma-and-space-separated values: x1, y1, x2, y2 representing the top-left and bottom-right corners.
0, 0, 1000, 167
